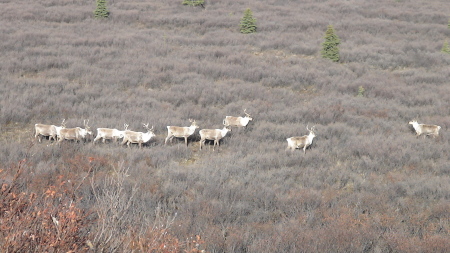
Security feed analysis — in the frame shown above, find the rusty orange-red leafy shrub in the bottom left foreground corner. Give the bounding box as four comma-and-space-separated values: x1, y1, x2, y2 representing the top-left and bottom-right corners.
0, 160, 91, 252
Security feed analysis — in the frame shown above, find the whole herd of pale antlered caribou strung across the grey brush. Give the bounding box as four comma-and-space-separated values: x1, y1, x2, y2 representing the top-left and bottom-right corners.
34, 110, 441, 153
